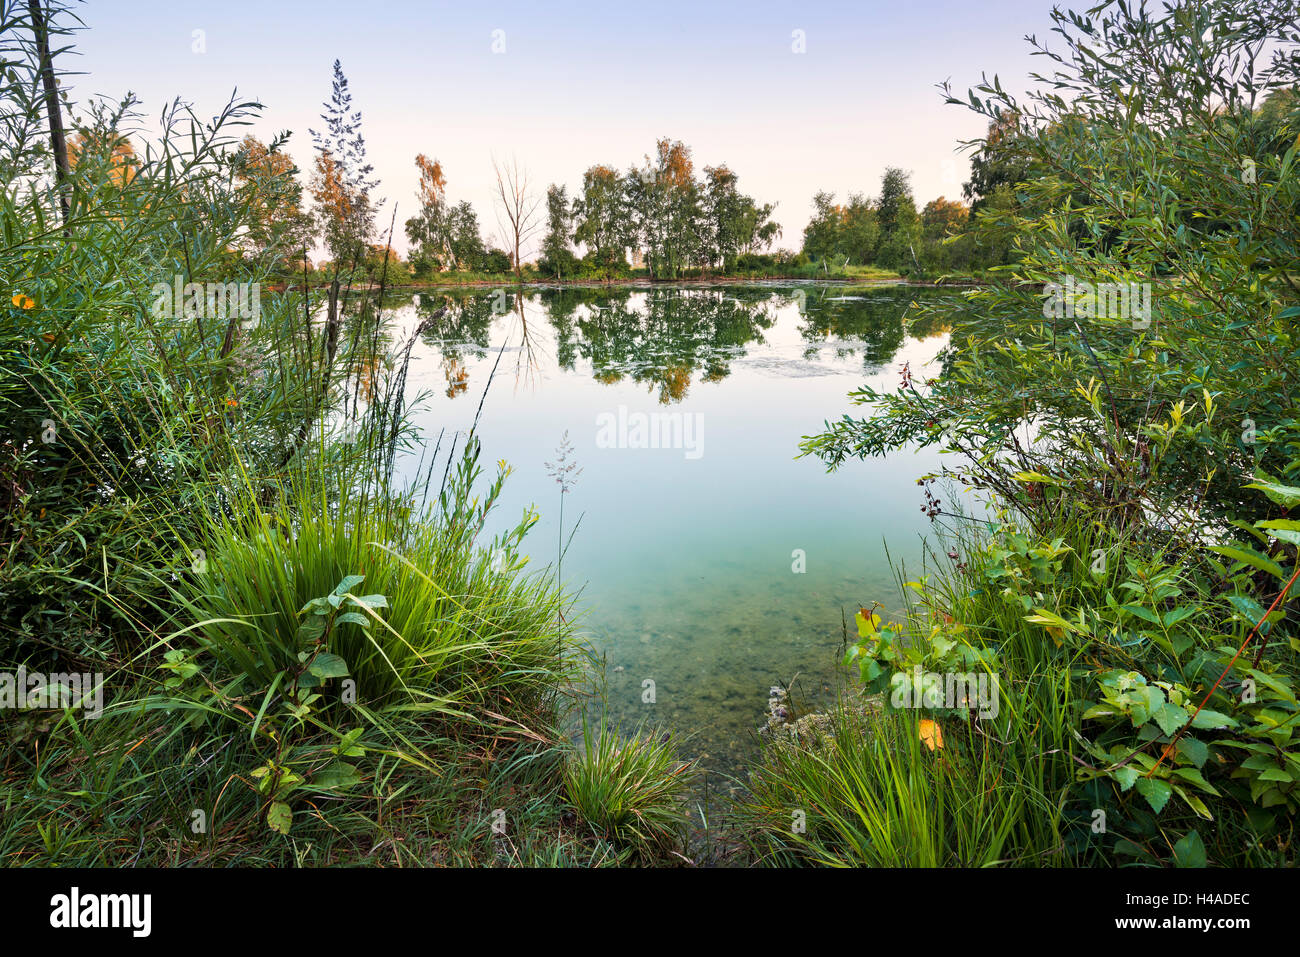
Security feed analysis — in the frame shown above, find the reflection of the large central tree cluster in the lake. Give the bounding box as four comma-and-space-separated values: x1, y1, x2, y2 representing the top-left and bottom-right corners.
542, 287, 775, 404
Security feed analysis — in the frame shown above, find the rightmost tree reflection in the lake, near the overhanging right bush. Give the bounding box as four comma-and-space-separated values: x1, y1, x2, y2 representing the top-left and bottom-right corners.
790, 287, 965, 371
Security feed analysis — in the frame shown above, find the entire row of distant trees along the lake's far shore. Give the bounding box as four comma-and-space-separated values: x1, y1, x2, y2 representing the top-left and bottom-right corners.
234, 61, 1206, 280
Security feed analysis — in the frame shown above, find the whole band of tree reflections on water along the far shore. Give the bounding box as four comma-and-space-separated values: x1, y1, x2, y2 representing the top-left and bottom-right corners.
395, 285, 962, 404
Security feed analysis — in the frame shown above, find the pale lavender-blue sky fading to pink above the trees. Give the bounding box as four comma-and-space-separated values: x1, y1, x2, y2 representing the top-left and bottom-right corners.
65, 0, 1050, 256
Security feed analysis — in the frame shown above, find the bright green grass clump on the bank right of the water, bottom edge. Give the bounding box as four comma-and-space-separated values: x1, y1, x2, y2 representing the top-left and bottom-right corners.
737, 710, 1061, 867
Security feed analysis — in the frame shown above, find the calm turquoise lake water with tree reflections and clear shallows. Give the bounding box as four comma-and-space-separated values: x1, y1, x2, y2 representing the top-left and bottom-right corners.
379, 283, 957, 788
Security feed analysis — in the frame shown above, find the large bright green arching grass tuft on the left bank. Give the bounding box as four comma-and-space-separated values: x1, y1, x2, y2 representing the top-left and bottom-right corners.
182, 442, 568, 733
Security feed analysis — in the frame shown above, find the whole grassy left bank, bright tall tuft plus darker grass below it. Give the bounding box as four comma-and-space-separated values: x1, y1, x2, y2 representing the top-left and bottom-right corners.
0, 421, 595, 866
